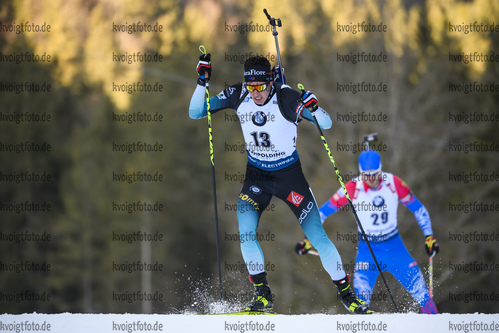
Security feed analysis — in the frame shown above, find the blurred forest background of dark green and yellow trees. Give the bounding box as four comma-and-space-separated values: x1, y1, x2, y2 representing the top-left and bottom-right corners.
0, 0, 499, 313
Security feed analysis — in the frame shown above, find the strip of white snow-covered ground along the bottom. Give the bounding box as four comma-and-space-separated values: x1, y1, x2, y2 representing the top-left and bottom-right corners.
0, 313, 499, 333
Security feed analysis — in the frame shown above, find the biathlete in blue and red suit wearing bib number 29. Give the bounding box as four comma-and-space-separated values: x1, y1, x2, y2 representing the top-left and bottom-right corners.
295, 150, 439, 314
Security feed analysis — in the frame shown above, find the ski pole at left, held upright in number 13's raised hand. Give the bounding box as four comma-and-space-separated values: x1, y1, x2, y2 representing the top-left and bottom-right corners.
199, 45, 223, 301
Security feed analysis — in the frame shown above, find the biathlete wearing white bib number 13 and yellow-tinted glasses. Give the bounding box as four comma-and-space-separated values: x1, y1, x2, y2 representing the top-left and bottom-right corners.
189, 54, 370, 313
